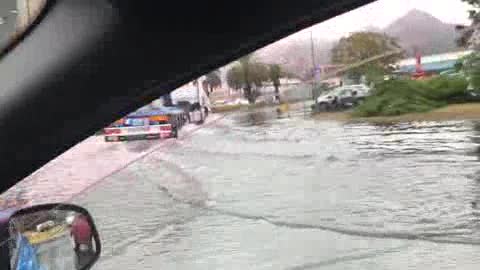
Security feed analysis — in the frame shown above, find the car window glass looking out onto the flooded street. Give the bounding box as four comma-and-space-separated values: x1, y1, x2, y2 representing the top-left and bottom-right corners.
4, 0, 480, 270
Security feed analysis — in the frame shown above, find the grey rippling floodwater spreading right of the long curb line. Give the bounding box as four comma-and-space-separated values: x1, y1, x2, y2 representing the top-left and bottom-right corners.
12, 103, 480, 270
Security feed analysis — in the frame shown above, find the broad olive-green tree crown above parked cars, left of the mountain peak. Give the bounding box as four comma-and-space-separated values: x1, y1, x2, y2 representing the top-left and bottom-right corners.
332, 32, 403, 81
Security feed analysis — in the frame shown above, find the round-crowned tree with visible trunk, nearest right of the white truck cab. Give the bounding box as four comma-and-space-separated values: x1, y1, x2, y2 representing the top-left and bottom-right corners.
227, 54, 268, 103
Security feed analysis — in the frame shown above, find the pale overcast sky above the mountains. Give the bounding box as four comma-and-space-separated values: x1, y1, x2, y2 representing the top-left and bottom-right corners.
297, 0, 470, 39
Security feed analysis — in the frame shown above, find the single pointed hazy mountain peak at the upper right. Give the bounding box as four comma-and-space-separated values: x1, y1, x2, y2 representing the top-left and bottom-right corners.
383, 10, 458, 56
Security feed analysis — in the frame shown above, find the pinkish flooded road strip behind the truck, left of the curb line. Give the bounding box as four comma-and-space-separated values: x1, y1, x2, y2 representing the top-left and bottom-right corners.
2, 115, 223, 205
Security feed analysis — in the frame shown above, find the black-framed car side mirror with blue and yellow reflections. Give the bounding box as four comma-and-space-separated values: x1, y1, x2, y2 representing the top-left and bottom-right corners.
8, 204, 101, 270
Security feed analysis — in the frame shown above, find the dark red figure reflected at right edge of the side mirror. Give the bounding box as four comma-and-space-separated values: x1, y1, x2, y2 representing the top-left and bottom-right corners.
70, 214, 95, 269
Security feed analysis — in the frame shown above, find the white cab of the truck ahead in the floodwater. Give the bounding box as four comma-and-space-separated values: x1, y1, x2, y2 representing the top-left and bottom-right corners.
170, 82, 211, 124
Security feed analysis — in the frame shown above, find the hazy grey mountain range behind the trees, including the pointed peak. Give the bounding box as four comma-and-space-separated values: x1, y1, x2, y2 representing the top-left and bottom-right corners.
244, 10, 459, 77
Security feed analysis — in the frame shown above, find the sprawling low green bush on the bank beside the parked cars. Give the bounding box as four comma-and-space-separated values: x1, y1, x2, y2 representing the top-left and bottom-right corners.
354, 76, 468, 117
